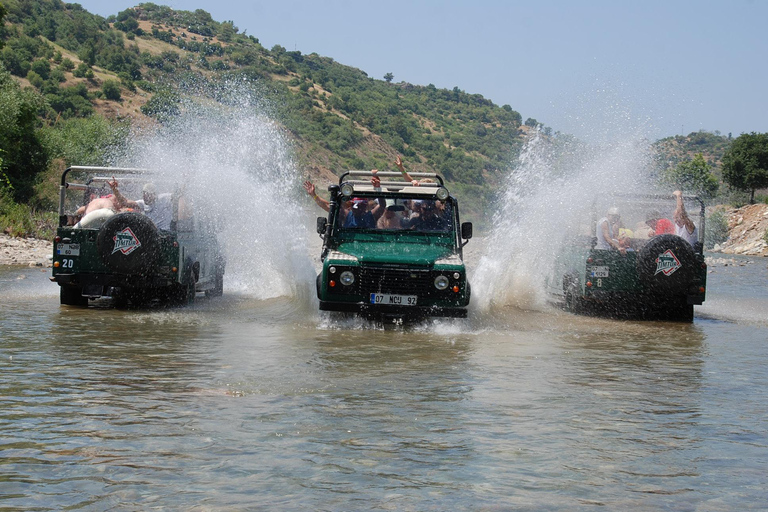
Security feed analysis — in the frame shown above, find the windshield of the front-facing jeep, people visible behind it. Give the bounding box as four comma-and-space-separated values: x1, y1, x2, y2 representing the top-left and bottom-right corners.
336, 197, 453, 233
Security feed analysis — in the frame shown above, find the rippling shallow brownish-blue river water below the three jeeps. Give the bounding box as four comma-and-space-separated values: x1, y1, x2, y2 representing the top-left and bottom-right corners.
0, 253, 768, 511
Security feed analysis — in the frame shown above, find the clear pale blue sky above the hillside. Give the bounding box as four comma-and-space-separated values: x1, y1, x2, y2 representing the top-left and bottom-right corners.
73, 0, 768, 140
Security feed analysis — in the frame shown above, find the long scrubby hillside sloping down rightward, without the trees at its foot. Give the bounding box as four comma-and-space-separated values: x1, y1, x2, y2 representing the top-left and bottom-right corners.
0, 0, 537, 219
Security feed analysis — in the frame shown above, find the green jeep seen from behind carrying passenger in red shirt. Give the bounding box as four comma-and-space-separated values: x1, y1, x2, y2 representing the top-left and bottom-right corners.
554, 195, 707, 322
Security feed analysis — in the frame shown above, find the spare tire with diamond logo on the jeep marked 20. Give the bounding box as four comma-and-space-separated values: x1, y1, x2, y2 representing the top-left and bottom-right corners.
96, 213, 160, 275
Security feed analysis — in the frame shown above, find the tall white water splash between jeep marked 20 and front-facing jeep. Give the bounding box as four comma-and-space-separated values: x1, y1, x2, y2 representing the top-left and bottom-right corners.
110, 84, 314, 303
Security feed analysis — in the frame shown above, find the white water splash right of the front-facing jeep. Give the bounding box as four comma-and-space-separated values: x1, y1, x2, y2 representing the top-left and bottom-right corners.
472, 133, 651, 313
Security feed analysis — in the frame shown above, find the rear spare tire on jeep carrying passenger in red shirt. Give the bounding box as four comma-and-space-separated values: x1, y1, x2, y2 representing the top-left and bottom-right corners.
637, 235, 696, 294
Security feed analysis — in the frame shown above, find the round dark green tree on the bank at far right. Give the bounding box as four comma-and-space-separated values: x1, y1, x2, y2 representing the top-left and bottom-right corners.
723, 132, 768, 204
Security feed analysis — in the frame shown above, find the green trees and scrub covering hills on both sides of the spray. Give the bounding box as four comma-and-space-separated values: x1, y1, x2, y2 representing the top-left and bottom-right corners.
0, 0, 764, 240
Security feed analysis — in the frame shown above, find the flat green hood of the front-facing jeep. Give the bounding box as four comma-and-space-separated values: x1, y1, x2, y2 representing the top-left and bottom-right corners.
336, 241, 453, 266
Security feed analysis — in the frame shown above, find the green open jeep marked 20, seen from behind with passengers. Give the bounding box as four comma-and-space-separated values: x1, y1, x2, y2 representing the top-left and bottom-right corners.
51, 166, 225, 306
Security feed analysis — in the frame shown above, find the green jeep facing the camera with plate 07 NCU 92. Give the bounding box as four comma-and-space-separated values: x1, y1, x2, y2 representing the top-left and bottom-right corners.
317, 171, 472, 321
